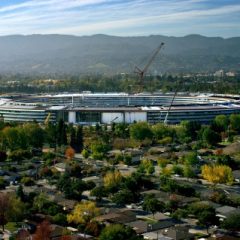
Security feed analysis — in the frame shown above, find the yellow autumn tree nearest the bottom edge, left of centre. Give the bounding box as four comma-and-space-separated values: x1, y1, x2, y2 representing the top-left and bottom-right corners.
67, 201, 100, 224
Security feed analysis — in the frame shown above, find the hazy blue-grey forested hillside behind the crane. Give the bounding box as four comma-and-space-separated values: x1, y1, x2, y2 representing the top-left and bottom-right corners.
0, 35, 240, 74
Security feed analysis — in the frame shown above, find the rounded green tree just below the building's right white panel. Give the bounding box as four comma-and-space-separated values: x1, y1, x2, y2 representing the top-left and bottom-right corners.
130, 122, 153, 141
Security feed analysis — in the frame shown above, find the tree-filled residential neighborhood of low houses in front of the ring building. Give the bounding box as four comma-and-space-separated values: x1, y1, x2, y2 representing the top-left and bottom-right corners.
0, 115, 240, 240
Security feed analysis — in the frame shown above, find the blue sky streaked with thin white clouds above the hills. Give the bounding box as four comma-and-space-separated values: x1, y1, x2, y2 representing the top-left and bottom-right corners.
0, 0, 240, 37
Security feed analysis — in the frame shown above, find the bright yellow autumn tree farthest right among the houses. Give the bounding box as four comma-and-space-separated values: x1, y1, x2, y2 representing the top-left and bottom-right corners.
202, 165, 234, 184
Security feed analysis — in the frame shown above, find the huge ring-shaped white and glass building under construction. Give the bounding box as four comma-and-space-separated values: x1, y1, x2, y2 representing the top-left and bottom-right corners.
0, 92, 240, 125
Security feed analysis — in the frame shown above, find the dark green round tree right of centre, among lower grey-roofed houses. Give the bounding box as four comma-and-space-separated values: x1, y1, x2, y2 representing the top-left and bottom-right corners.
142, 194, 164, 215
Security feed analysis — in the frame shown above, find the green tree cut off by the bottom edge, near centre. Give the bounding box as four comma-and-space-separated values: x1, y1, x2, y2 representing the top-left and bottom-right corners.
99, 224, 142, 240
